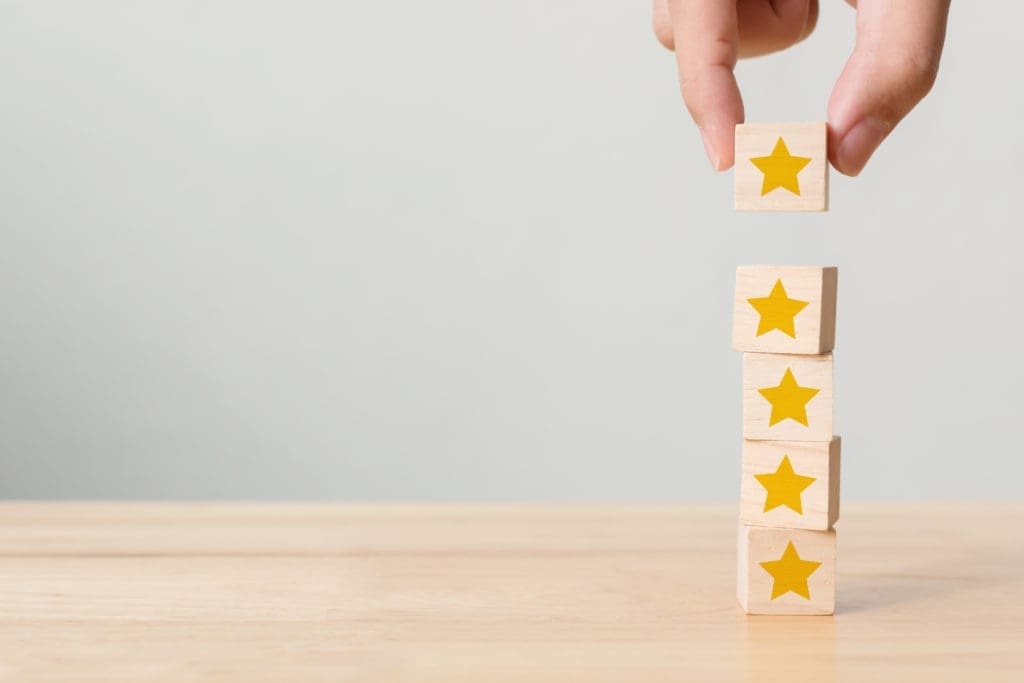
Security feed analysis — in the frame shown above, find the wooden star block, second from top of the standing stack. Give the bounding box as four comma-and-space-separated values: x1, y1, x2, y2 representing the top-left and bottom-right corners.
743, 353, 833, 441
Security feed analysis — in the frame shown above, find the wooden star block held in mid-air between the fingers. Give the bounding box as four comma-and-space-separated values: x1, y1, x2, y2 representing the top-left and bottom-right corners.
735, 122, 828, 211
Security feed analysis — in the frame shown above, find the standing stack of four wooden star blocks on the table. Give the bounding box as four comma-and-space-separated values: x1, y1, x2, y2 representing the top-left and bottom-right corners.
732, 265, 841, 614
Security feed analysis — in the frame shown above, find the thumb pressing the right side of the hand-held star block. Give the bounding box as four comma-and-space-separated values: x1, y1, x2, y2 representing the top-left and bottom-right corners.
828, 0, 949, 175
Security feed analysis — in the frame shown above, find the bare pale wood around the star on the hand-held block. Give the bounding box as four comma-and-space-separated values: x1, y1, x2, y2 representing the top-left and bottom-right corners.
734, 121, 828, 211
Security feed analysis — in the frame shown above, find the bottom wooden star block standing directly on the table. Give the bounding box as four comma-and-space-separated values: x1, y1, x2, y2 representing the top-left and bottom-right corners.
736, 524, 836, 614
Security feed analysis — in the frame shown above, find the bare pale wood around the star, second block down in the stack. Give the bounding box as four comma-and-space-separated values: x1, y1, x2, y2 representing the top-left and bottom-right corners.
743, 353, 835, 441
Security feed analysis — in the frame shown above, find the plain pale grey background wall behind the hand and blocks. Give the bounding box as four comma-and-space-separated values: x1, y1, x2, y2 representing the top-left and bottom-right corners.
0, 0, 1024, 500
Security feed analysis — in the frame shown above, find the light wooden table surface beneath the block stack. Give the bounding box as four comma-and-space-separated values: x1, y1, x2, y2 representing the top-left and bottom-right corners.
0, 503, 1024, 683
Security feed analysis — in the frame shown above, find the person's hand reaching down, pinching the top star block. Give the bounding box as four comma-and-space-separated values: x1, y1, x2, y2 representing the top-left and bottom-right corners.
654, 0, 950, 175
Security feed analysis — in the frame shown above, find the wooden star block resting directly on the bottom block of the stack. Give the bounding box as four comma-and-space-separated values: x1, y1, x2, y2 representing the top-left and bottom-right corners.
739, 436, 840, 531
